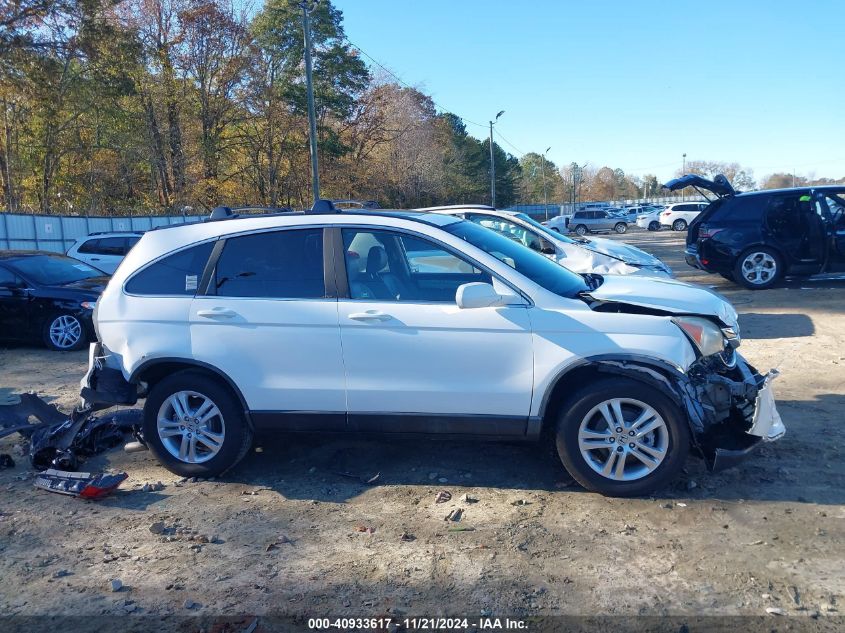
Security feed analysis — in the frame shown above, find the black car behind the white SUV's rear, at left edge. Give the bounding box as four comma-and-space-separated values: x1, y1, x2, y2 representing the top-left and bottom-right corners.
0, 251, 109, 351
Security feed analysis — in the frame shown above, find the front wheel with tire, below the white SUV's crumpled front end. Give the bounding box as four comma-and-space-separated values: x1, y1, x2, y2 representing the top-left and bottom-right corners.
555, 378, 690, 497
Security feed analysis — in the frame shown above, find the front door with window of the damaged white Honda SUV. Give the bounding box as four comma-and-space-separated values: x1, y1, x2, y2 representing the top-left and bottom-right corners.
338, 228, 533, 435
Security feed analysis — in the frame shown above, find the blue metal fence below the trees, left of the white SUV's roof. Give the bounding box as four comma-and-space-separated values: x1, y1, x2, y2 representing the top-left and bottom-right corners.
0, 213, 205, 253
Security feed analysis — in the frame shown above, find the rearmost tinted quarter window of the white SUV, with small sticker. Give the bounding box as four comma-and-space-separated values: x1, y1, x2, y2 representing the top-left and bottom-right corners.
126, 242, 214, 297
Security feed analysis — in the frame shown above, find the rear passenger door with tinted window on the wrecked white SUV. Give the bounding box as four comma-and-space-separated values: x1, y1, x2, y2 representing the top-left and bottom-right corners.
190, 228, 346, 430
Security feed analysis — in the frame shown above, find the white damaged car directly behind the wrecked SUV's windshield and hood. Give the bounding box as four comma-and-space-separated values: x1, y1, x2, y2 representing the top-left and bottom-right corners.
418, 205, 672, 277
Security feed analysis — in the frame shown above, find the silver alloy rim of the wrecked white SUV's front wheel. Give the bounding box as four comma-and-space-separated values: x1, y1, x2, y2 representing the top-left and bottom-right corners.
578, 398, 669, 481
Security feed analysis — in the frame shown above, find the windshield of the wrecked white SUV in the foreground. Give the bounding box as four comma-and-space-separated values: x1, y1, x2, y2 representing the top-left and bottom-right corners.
443, 222, 588, 299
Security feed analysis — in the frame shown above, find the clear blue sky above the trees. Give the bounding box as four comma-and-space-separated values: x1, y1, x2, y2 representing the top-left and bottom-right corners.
334, 0, 845, 179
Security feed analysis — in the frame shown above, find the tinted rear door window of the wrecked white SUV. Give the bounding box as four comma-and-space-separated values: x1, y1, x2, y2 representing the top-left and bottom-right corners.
210, 229, 326, 299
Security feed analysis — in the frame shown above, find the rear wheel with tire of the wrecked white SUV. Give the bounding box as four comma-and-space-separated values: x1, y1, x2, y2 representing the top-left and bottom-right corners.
143, 370, 252, 477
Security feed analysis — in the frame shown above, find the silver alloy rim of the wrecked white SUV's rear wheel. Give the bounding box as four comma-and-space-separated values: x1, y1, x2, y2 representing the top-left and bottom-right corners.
156, 391, 226, 464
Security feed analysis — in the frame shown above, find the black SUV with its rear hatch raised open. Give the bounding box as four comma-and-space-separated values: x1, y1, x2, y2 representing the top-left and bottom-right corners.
664, 174, 845, 290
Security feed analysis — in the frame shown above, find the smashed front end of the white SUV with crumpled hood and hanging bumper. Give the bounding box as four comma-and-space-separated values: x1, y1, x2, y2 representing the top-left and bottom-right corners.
586, 277, 786, 471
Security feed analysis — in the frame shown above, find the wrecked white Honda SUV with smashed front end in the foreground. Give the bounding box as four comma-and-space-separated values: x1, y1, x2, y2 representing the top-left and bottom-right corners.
82, 202, 784, 496
